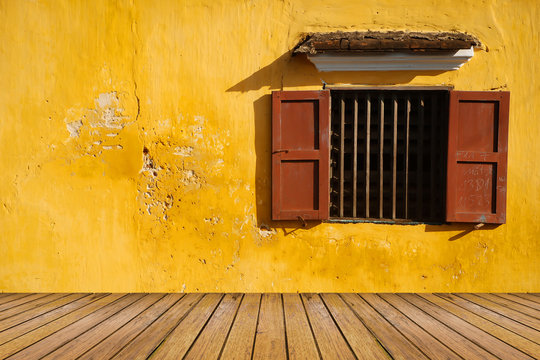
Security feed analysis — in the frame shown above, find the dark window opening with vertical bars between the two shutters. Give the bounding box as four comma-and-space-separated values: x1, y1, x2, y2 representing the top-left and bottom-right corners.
330, 90, 448, 222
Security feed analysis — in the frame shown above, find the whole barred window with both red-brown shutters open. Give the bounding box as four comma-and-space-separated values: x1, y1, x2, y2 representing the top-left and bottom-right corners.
272, 89, 509, 223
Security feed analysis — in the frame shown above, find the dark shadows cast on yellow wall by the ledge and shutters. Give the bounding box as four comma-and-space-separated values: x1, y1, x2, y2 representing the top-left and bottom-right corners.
227, 51, 460, 235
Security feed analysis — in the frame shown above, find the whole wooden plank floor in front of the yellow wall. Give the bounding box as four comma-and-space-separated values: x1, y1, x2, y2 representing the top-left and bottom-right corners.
0, 294, 540, 360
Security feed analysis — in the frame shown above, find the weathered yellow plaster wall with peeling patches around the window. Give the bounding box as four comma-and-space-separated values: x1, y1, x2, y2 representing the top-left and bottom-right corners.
0, 0, 540, 292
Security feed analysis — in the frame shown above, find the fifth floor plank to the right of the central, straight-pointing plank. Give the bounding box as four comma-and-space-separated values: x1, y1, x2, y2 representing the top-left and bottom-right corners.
361, 294, 460, 359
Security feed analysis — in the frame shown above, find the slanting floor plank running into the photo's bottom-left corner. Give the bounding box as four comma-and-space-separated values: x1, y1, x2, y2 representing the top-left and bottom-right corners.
0, 294, 125, 358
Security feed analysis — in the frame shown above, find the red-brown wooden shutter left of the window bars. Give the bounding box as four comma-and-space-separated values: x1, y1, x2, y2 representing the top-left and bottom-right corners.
272, 90, 330, 220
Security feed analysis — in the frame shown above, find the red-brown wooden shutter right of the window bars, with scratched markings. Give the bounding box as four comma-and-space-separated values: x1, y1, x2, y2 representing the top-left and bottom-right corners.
446, 91, 510, 224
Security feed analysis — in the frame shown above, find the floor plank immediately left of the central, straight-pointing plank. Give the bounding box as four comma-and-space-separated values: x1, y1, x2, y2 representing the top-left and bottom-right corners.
221, 294, 261, 360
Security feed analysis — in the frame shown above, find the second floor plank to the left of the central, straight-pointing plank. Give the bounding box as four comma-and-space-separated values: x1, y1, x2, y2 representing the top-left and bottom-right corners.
184, 294, 242, 360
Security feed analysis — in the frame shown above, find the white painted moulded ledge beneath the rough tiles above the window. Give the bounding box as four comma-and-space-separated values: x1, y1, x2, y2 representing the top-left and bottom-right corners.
308, 47, 474, 72
